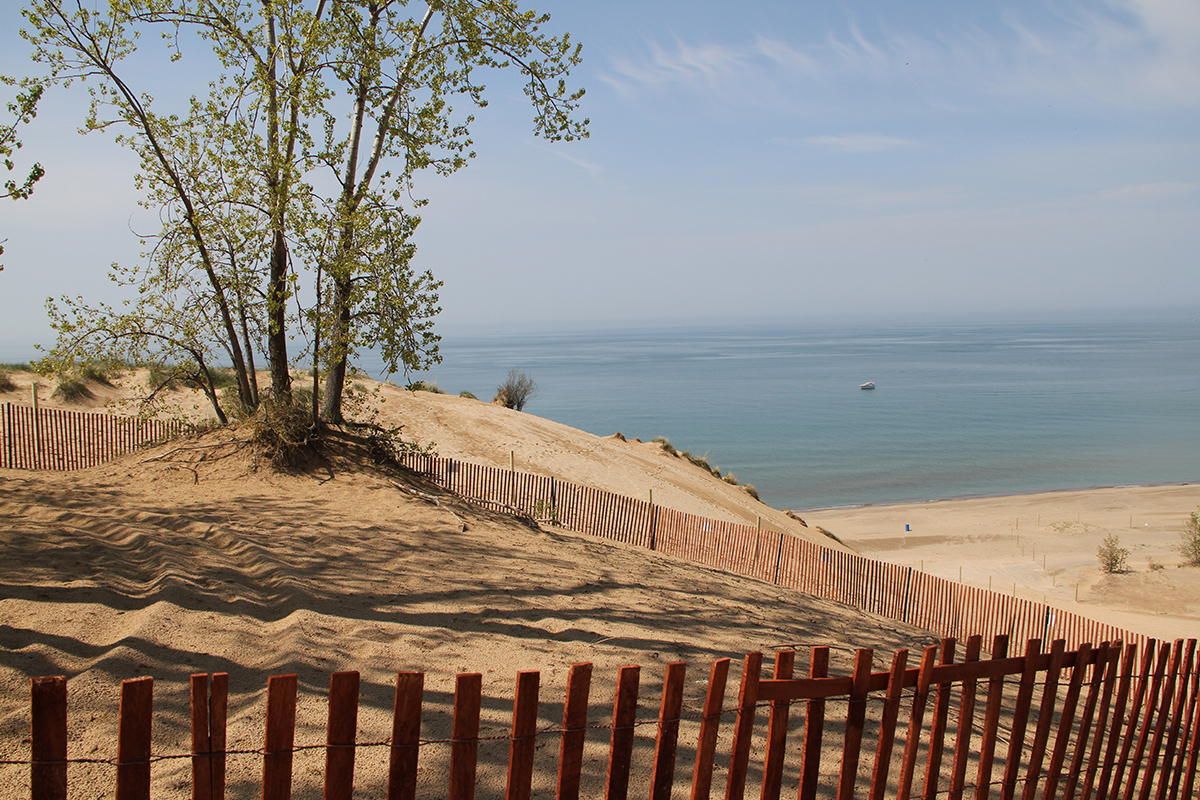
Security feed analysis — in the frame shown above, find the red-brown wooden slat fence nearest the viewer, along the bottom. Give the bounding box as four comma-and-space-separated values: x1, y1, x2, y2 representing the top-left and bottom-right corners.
5, 636, 1200, 800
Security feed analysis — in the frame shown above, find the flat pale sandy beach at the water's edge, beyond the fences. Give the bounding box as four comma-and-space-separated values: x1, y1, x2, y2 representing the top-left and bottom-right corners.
802, 485, 1200, 639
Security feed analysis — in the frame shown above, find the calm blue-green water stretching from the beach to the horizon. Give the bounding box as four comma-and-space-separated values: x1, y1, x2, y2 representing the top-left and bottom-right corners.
396, 315, 1200, 509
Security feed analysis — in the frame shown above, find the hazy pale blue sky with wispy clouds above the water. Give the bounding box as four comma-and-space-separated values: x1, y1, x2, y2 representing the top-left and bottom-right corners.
0, 0, 1200, 357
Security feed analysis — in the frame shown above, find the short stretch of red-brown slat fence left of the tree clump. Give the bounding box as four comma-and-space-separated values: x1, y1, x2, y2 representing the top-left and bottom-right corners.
0, 403, 184, 470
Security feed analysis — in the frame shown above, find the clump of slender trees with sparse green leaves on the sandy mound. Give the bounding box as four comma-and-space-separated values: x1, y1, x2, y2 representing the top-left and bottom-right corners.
25, 0, 587, 421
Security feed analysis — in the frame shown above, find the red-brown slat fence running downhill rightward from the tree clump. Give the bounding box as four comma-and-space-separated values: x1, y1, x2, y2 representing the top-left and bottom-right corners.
401, 453, 1146, 648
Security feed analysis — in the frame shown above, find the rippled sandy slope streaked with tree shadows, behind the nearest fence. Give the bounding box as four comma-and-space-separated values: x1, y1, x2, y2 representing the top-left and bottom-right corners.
0, 433, 929, 796
